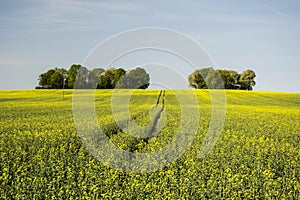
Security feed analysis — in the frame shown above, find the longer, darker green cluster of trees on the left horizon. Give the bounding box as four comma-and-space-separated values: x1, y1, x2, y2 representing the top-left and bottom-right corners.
36, 64, 150, 89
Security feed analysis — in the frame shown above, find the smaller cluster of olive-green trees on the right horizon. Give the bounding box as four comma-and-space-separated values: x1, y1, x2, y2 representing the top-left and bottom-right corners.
188, 67, 256, 90
